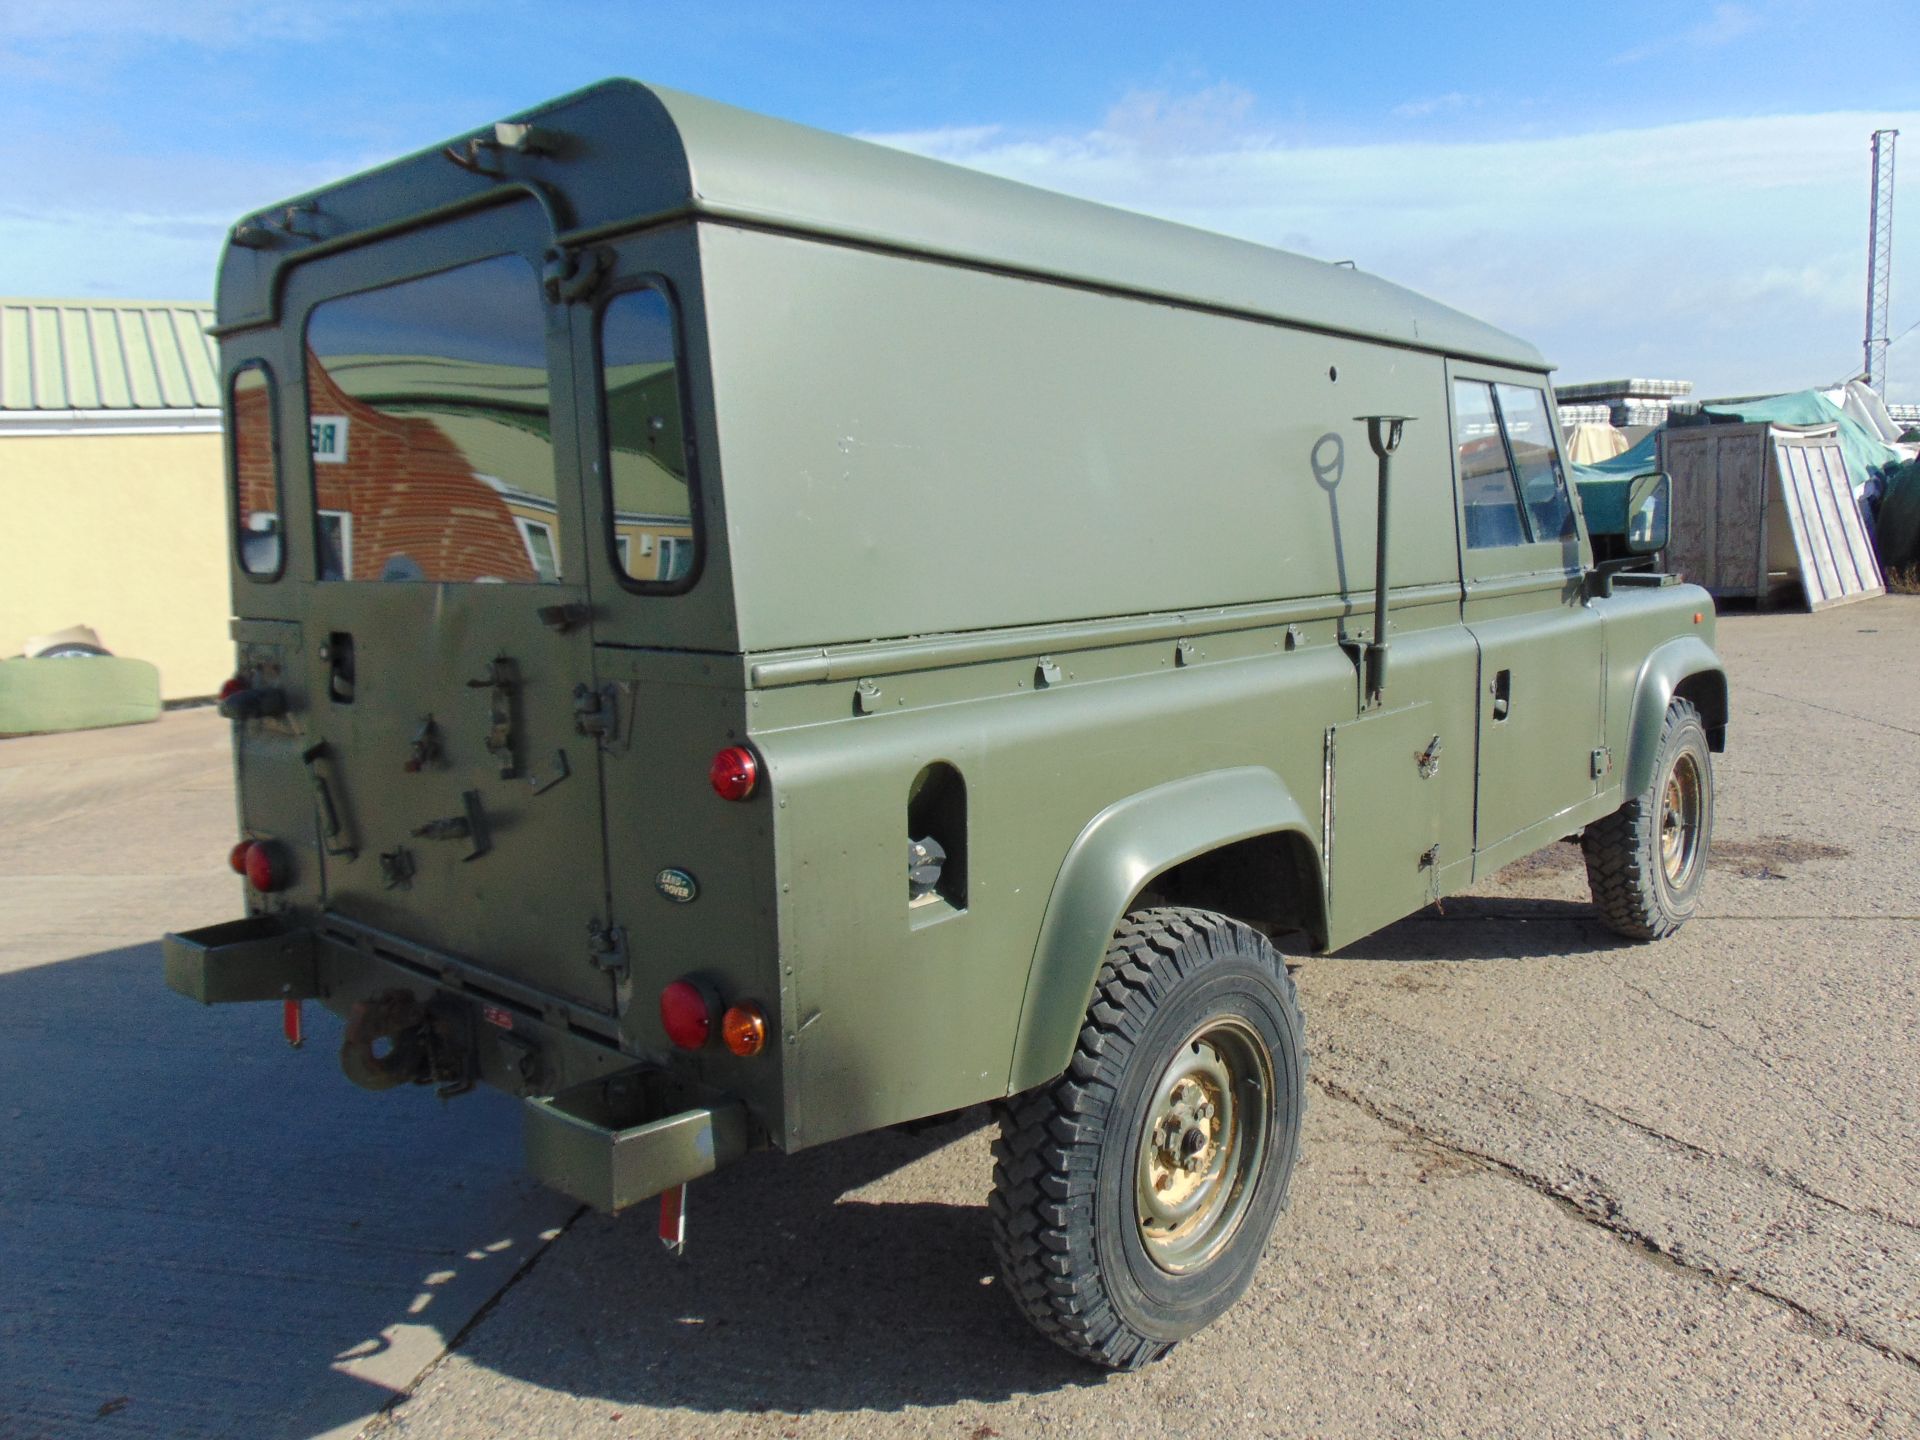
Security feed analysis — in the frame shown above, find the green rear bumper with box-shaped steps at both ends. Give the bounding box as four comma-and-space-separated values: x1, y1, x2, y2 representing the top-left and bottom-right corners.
161, 916, 753, 1213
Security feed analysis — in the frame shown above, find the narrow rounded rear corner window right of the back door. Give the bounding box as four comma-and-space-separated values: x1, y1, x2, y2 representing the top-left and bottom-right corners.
601, 290, 697, 586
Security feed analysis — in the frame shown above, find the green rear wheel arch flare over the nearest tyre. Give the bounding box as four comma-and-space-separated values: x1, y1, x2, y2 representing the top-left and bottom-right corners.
1006, 766, 1327, 1094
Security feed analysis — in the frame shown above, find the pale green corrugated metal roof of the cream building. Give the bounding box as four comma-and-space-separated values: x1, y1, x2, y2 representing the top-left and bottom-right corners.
0, 300, 221, 411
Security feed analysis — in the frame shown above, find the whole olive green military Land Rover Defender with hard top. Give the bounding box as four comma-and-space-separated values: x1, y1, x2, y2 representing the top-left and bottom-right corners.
165, 81, 1728, 1367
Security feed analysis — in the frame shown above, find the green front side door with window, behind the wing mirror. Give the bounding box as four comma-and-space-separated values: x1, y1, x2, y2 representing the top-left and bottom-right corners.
1448, 363, 1605, 876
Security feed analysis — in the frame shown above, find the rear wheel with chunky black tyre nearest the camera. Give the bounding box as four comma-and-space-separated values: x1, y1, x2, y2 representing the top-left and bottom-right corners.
987, 910, 1306, 1369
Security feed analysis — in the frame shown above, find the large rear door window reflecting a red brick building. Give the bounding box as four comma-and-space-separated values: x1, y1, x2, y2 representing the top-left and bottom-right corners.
307, 255, 563, 584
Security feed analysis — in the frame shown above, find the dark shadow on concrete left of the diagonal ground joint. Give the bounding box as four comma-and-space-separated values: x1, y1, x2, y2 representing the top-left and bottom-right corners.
0, 945, 574, 1440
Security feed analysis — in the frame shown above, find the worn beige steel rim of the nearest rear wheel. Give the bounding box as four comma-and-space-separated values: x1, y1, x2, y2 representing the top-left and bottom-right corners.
1135, 1018, 1273, 1275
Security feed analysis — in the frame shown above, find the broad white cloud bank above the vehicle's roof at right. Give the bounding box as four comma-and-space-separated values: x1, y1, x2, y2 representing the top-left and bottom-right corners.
874, 104, 1920, 399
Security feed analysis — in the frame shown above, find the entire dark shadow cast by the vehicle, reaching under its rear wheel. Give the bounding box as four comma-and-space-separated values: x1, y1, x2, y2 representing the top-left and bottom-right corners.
0, 945, 1098, 1440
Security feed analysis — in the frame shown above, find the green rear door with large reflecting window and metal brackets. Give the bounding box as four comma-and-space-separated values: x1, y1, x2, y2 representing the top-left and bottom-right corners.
284, 204, 616, 1014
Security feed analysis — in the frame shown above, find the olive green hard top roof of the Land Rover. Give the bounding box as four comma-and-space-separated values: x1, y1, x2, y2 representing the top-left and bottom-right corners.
219, 81, 1548, 371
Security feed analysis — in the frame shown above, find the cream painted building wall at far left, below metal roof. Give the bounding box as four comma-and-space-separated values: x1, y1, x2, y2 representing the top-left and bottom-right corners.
0, 434, 234, 701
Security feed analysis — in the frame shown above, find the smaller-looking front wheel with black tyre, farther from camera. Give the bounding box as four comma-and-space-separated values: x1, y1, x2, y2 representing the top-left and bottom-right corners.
1580, 699, 1713, 941
